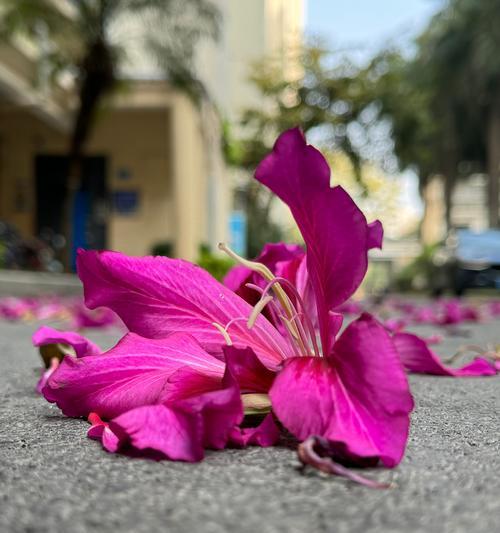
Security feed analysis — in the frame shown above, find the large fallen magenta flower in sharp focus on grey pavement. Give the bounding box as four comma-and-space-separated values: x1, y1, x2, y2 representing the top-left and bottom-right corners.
34, 129, 496, 480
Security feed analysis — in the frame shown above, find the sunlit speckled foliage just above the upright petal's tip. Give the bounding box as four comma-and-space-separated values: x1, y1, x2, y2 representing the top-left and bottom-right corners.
234, 46, 370, 177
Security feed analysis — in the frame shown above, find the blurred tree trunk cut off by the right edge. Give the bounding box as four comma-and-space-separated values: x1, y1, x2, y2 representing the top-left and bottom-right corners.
487, 98, 500, 228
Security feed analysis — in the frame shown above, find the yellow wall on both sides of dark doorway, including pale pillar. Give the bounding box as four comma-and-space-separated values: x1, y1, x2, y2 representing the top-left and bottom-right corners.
0, 103, 207, 259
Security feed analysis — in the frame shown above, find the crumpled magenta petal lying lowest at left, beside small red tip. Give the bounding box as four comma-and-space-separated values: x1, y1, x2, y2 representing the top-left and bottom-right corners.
108, 405, 203, 462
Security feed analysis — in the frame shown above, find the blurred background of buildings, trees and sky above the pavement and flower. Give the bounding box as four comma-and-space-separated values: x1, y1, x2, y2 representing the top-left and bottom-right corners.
0, 0, 500, 300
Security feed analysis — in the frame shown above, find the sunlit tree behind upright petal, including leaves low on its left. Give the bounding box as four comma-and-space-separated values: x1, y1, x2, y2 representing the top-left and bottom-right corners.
230, 46, 378, 256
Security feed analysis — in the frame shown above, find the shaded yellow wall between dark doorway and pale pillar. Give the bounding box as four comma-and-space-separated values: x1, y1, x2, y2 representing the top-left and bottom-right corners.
88, 110, 175, 255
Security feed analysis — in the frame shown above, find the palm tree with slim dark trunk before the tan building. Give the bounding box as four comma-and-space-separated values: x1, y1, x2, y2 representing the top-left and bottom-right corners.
0, 0, 220, 266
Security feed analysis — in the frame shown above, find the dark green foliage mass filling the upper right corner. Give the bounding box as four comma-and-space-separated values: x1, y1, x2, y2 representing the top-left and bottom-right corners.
360, 0, 500, 224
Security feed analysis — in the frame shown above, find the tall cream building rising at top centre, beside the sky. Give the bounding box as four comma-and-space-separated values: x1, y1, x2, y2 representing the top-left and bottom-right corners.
198, 0, 305, 124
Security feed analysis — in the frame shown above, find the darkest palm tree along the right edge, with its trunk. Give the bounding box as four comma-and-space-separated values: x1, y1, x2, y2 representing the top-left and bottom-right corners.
418, 0, 500, 227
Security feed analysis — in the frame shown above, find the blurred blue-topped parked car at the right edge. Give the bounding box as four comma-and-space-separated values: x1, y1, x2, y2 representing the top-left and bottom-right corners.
432, 229, 500, 296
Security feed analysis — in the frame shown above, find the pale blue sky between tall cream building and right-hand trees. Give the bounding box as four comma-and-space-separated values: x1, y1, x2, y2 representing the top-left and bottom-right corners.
305, 0, 444, 218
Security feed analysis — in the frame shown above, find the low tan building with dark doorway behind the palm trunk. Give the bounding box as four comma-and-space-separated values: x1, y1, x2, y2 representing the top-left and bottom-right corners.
0, 37, 217, 259
